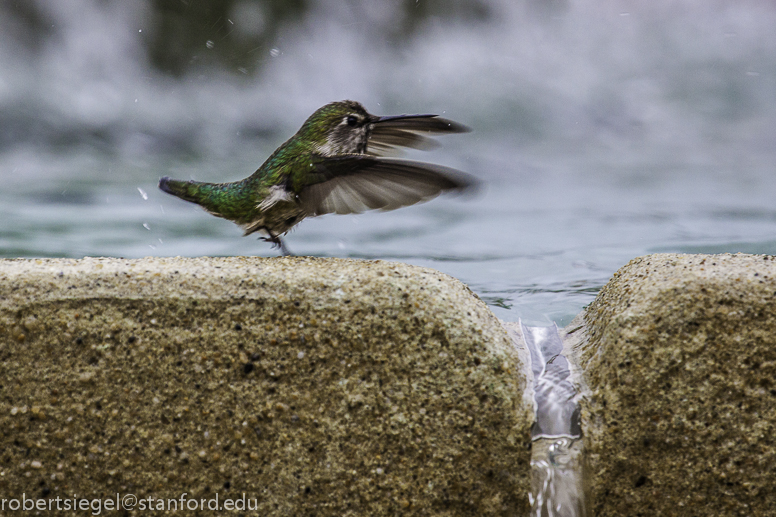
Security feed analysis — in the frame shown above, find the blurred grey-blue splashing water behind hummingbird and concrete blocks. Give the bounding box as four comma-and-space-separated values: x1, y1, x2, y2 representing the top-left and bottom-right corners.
0, 0, 776, 325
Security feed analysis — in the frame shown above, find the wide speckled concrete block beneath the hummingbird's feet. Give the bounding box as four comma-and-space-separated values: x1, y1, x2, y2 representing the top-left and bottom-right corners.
0, 258, 532, 516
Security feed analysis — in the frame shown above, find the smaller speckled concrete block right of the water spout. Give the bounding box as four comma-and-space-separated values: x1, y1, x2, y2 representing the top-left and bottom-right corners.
566, 254, 776, 517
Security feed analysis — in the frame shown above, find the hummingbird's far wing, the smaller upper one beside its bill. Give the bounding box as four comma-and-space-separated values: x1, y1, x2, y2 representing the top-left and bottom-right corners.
367, 115, 469, 155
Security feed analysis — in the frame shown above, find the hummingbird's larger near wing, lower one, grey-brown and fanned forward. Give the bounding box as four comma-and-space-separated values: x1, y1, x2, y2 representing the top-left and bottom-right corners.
299, 154, 476, 215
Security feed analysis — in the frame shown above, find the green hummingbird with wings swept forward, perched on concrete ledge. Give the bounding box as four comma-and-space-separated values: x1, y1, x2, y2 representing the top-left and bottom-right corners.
159, 100, 477, 255
